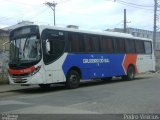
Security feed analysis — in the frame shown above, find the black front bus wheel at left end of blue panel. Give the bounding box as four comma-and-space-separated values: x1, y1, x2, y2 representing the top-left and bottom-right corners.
66, 70, 80, 89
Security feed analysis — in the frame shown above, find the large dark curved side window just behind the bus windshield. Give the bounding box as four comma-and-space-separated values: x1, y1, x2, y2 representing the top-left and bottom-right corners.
42, 29, 65, 64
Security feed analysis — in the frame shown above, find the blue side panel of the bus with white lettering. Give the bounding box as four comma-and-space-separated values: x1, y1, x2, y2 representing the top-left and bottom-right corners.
62, 54, 125, 79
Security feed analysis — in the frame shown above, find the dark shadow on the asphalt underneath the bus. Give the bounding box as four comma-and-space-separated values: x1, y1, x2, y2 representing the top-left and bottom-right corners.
1, 77, 149, 94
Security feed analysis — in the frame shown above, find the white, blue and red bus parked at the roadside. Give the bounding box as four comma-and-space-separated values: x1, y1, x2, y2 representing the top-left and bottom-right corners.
8, 25, 155, 88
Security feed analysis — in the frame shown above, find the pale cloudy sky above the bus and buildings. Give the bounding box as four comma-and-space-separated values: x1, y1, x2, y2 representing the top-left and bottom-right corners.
0, 0, 154, 30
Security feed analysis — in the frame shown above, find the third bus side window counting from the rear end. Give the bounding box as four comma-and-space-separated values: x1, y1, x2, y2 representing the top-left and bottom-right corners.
125, 39, 136, 53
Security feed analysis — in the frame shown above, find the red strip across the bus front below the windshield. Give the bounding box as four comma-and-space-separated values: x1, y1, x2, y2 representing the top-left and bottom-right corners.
8, 66, 36, 75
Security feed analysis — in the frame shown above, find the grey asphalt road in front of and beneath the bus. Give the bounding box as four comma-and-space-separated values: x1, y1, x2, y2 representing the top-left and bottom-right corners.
0, 74, 160, 119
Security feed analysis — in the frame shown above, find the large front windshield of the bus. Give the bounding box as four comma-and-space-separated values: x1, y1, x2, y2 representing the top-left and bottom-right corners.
10, 35, 41, 64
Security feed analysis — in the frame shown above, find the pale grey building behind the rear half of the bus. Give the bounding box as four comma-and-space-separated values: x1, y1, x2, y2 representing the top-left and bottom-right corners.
106, 28, 160, 50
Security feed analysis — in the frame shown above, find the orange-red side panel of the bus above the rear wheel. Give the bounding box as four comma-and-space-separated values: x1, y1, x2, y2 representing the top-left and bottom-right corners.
123, 54, 138, 73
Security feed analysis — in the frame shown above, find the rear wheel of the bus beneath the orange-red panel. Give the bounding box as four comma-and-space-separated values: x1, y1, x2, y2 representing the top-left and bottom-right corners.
122, 65, 135, 80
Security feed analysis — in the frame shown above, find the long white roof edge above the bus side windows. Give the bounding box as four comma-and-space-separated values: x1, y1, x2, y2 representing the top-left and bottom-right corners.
34, 25, 152, 41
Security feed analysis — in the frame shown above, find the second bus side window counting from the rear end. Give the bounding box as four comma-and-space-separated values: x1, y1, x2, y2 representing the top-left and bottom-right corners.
136, 40, 145, 54
